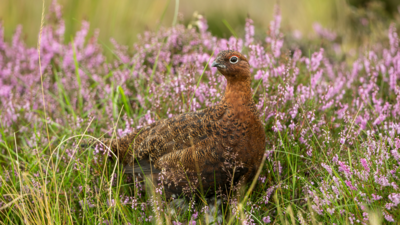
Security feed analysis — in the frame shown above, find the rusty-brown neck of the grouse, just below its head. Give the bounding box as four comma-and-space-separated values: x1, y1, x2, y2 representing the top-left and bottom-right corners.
223, 79, 253, 108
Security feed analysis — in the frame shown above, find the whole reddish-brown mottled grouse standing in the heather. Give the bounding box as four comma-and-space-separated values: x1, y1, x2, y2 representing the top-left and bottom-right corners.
82, 50, 266, 197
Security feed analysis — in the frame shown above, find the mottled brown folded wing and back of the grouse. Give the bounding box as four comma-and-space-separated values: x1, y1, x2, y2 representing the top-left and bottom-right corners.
81, 106, 226, 171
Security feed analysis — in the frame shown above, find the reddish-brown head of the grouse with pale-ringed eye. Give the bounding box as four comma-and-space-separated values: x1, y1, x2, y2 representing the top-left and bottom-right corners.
211, 50, 250, 80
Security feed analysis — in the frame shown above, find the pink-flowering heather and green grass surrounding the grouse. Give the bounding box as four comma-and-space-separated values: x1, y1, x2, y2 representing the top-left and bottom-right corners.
0, 1, 400, 224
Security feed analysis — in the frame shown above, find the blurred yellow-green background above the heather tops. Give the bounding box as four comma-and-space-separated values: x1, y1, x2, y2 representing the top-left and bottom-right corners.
0, 0, 400, 46
